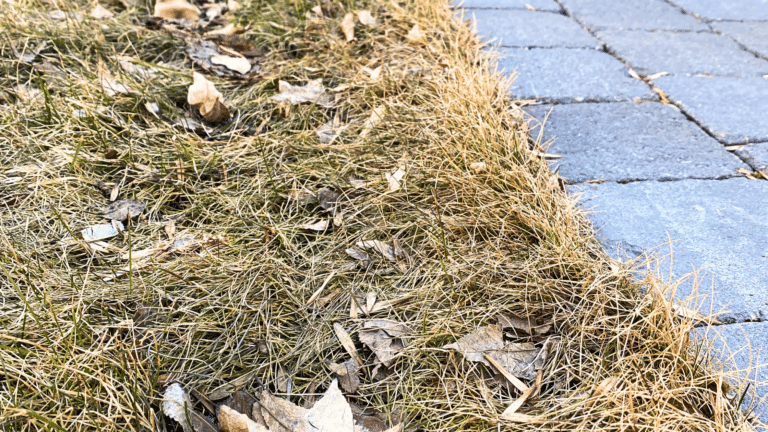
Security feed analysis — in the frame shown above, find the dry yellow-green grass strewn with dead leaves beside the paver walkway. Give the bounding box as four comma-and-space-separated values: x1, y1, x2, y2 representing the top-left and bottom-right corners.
0, 0, 756, 431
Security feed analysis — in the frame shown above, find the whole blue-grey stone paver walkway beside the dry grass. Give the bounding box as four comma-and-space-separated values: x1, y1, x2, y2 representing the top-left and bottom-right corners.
462, 0, 768, 422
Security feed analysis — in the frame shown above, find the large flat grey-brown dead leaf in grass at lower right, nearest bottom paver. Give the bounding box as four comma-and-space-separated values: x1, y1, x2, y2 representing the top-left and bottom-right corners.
444, 325, 538, 382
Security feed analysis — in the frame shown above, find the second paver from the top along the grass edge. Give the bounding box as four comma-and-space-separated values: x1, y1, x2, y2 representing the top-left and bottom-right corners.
467, 9, 602, 48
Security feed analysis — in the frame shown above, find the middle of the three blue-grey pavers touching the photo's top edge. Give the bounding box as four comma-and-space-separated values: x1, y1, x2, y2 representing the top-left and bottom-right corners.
562, 0, 709, 30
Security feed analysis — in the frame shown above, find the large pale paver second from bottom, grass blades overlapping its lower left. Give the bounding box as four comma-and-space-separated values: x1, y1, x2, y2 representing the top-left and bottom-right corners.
569, 178, 768, 322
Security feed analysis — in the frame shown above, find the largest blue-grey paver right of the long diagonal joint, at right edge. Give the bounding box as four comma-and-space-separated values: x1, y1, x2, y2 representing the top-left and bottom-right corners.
653, 76, 768, 144
